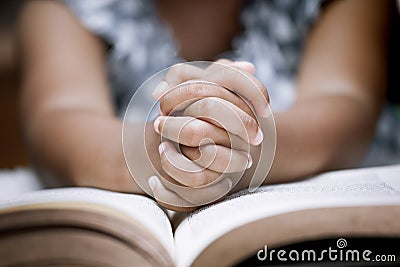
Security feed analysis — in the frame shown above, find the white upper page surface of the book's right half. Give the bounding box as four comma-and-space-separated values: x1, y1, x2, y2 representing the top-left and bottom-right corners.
175, 165, 400, 266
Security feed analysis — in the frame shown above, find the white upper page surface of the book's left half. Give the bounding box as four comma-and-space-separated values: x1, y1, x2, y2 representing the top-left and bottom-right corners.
0, 188, 175, 259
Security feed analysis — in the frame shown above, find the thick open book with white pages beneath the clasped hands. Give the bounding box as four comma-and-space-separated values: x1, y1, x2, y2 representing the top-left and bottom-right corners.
0, 165, 400, 266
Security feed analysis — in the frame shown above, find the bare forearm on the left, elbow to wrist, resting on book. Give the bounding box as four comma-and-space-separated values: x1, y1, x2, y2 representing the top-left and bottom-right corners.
25, 110, 146, 193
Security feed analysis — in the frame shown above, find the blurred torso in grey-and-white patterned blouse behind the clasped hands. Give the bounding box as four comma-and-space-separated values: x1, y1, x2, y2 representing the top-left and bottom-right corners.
61, 0, 400, 165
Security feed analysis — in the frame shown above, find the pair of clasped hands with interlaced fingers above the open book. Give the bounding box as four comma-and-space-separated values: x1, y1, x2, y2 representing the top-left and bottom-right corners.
150, 61, 268, 210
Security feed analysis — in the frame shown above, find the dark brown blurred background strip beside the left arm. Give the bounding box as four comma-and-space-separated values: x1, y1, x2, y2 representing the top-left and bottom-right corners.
0, 0, 28, 168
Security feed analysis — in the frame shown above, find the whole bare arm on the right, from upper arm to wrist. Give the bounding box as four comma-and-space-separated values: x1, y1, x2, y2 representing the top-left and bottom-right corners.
242, 0, 391, 188
